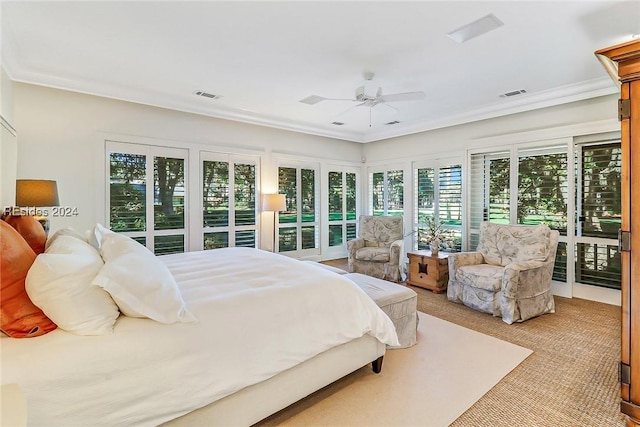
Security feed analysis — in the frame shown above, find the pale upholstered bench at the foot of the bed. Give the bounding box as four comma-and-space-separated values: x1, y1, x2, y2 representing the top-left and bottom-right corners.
344, 273, 418, 348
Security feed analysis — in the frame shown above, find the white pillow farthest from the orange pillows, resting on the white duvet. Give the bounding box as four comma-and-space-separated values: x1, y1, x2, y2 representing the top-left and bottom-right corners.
92, 232, 196, 323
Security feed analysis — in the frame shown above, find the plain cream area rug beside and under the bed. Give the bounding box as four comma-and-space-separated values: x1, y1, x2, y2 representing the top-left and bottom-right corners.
259, 313, 532, 427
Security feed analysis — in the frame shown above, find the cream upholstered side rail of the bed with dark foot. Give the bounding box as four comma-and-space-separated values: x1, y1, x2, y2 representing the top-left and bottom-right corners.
163, 335, 386, 427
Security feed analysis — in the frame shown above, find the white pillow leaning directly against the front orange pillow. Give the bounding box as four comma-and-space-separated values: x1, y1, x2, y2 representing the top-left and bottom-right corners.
25, 234, 120, 335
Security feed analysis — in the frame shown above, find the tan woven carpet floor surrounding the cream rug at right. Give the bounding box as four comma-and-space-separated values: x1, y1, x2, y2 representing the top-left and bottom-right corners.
304, 260, 625, 427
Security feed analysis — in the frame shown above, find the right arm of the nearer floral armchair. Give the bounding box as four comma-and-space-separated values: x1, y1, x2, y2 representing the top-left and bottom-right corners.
502, 259, 555, 298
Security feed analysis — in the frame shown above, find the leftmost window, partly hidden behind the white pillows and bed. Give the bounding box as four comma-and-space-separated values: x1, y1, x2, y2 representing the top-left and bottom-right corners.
107, 142, 187, 254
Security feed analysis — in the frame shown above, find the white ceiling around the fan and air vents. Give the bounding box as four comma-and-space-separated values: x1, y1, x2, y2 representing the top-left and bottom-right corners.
0, 0, 640, 142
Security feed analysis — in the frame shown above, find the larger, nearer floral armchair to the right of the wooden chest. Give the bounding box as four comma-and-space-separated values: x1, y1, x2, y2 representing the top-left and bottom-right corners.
447, 222, 559, 324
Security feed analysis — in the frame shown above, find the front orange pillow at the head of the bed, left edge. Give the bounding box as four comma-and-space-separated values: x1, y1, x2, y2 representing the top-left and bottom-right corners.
0, 221, 57, 338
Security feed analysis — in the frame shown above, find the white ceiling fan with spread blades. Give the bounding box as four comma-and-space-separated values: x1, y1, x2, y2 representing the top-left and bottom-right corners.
300, 73, 425, 127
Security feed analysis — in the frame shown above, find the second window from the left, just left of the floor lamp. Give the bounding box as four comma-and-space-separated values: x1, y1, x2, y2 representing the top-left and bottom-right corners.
202, 153, 258, 249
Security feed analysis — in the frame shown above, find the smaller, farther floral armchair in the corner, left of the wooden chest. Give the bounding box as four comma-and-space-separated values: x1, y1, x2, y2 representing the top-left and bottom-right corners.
347, 215, 404, 282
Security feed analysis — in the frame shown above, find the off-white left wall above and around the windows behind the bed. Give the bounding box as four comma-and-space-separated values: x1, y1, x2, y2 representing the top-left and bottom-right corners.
14, 82, 362, 241
